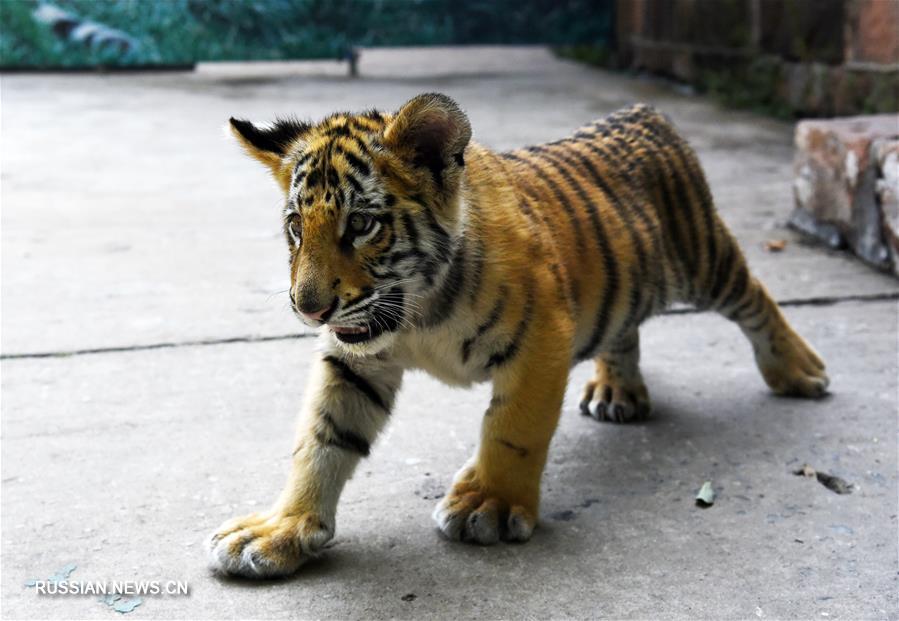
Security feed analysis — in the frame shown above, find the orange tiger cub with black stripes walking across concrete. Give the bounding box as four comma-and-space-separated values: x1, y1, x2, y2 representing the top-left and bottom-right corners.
207, 94, 828, 577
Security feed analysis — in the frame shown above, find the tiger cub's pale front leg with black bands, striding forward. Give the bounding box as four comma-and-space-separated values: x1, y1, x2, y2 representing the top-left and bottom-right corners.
207, 352, 402, 577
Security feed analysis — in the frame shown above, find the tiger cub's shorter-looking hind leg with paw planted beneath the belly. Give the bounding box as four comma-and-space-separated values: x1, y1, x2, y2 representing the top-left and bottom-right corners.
581, 328, 650, 423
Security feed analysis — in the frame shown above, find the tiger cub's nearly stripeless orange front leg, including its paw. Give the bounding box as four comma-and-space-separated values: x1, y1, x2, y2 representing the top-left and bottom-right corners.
434, 326, 570, 544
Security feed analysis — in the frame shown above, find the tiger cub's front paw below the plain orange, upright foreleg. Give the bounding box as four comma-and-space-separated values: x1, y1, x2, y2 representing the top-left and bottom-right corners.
433, 471, 537, 545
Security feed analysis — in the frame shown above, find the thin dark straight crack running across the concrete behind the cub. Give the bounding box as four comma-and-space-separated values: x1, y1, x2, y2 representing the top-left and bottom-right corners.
0, 291, 899, 360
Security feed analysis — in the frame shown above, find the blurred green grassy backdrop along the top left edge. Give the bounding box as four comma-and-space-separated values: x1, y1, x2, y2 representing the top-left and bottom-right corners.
0, 0, 613, 67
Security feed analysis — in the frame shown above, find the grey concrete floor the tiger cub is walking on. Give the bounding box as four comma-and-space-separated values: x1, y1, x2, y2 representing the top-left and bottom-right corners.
0, 48, 899, 619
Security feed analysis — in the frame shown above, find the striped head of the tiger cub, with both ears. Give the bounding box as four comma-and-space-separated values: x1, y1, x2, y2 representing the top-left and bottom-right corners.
231, 94, 471, 354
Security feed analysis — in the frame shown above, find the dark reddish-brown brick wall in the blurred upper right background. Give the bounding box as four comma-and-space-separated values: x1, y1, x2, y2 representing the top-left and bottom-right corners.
616, 0, 899, 116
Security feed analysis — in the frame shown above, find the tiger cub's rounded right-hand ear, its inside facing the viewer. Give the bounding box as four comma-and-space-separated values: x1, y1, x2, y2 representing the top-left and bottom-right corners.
384, 93, 471, 190
